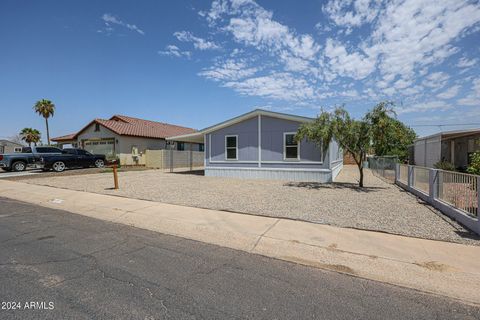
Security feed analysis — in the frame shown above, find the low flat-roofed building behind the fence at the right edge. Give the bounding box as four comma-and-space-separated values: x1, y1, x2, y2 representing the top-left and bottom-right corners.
414, 128, 480, 169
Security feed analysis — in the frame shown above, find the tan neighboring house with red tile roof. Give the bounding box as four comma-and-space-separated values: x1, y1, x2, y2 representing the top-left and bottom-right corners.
51, 115, 203, 165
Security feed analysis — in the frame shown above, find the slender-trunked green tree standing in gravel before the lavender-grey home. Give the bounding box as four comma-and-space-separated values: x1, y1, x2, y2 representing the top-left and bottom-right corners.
296, 107, 372, 187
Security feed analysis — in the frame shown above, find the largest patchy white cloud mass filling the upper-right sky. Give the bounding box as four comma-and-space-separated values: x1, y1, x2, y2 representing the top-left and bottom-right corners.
186, 0, 480, 113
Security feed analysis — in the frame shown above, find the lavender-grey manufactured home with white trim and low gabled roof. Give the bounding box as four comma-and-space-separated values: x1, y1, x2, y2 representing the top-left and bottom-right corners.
167, 109, 343, 182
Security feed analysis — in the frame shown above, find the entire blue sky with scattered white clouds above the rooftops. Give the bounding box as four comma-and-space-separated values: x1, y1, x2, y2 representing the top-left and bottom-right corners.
0, 0, 480, 142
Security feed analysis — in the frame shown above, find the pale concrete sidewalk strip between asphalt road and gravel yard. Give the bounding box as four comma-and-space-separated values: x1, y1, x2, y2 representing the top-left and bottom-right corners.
0, 180, 480, 305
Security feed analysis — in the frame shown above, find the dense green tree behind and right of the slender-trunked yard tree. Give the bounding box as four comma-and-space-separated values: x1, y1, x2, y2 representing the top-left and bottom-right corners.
365, 101, 417, 161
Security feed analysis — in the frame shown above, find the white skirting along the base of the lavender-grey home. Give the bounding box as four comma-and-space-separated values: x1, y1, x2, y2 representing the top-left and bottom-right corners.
205, 167, 332, 183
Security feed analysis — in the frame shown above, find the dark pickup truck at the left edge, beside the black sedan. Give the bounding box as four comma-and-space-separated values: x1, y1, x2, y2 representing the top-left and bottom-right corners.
0, 147, 62, 171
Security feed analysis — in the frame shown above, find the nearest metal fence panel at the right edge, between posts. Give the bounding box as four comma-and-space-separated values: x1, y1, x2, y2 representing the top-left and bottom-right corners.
437, 170, 478, 217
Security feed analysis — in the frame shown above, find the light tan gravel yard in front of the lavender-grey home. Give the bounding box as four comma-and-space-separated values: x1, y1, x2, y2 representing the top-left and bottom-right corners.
16, 166, 480, 245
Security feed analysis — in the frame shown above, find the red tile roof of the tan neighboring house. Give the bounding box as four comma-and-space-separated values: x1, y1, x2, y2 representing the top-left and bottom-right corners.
52, 115, 197, 141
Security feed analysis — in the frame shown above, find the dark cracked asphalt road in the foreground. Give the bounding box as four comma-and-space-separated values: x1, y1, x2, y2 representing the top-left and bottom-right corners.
0, 198, 480, 320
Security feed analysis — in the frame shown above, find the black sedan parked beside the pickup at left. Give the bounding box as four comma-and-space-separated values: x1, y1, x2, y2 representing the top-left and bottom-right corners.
41, 148, 106, 172
